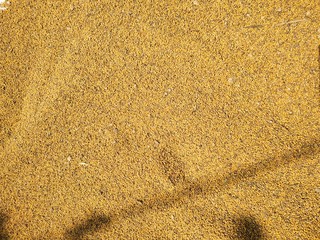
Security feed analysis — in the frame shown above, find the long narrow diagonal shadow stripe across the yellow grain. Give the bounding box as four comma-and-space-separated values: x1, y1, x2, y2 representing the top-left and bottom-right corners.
63, 139, 320, 239
